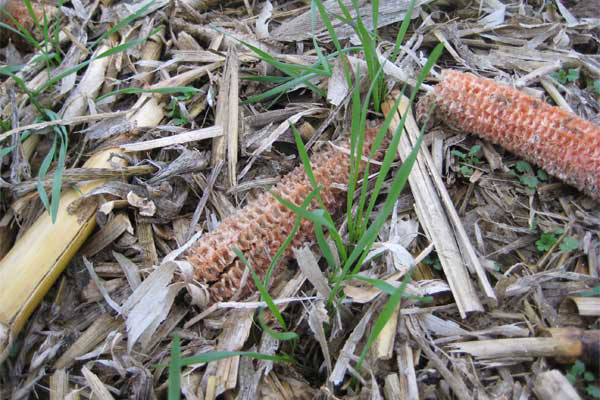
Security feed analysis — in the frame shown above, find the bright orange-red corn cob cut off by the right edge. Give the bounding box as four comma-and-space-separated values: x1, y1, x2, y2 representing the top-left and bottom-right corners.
419, 70, 600, 199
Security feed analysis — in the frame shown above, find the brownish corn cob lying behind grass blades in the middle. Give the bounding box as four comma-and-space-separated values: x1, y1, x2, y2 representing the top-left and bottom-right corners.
183, 123, 382, 302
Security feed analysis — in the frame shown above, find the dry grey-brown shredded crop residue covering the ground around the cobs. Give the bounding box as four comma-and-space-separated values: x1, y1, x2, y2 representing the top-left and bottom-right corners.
0, 0, 600, 399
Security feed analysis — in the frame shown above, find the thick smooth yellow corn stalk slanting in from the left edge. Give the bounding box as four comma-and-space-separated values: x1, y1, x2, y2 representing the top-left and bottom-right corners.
0, 97, 163, 362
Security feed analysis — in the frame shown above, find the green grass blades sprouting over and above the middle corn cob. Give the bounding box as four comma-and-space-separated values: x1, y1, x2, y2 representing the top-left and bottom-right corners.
169, 0, 443, 398
